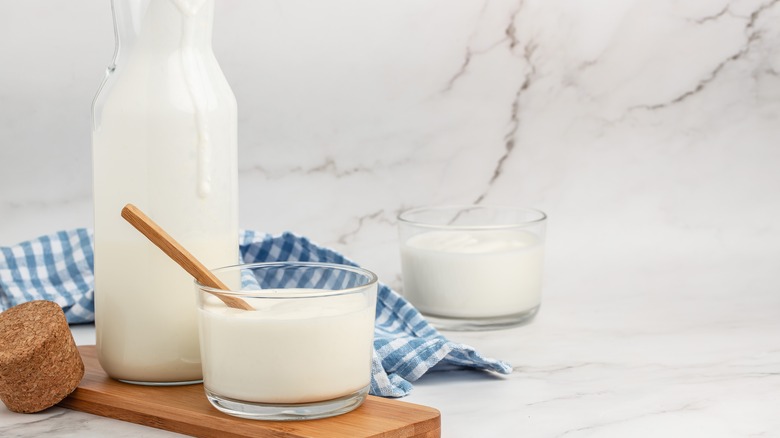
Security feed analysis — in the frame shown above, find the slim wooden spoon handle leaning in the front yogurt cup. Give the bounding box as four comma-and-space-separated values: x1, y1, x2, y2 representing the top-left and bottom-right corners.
122, 204, 254, 310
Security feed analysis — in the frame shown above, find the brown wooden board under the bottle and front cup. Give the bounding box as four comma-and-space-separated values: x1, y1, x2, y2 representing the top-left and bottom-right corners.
59, 345, 441, 438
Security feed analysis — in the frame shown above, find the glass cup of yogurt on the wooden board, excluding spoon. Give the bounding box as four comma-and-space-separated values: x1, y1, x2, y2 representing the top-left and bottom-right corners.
195, 262, 377, 420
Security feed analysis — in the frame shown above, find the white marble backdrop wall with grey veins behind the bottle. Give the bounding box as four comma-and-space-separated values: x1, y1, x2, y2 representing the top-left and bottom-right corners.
0, 0, 780, 285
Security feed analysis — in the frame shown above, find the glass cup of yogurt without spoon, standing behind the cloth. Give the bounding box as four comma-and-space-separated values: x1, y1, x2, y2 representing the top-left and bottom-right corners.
398, 205, 547, 330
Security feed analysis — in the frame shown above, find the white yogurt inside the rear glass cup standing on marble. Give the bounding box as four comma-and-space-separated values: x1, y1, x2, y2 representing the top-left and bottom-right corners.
401, 230, 543, 318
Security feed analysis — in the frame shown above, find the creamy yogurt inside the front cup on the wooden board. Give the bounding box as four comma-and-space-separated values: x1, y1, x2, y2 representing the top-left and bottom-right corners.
200, 290, 375, 403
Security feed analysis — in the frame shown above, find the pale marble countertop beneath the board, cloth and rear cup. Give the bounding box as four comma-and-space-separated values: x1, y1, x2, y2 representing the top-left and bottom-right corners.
0, 252, 780, 438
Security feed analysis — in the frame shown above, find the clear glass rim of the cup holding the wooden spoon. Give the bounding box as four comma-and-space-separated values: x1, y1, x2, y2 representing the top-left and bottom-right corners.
193, 260, 379, 299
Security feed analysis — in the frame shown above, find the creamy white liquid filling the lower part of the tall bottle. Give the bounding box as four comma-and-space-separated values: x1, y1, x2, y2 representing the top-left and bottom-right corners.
95, 236, 238, 382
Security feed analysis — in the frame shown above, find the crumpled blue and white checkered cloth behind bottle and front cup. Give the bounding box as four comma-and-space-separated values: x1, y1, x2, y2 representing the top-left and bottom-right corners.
0, 228, 512, 397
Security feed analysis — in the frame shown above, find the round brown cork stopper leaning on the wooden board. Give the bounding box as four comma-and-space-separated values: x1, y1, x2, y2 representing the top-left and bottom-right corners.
0, 301, 84, 413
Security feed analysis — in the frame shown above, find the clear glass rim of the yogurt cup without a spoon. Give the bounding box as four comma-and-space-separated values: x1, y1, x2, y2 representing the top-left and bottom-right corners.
397, 204, 547, 230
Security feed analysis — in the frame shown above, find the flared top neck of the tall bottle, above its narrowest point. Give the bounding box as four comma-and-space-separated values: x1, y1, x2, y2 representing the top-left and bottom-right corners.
112, 0, 214, 57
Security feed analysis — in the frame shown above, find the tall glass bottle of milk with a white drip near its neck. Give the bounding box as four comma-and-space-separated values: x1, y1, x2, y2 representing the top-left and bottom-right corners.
92, 0, 238, 385
